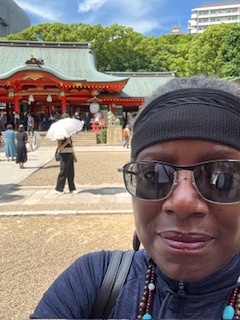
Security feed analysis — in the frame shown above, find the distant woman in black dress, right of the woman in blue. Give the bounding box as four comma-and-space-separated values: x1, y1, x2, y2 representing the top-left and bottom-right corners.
16, 124, 28, 169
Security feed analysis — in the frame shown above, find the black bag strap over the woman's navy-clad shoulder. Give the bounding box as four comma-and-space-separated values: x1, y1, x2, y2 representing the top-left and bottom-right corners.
92, 250, 135, 319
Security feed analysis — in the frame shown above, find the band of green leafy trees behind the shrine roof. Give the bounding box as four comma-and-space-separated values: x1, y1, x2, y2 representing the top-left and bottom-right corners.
2, 22, 240, 78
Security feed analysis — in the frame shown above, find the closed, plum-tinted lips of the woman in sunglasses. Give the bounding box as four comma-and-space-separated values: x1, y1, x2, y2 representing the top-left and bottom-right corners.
160, 231, 213, 253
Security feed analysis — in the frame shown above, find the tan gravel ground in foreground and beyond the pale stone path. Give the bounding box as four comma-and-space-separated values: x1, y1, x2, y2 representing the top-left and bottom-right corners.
0, 152, 134, 320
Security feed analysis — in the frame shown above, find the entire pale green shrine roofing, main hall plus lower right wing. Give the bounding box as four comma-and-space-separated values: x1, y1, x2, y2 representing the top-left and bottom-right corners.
0, 41, 176, 98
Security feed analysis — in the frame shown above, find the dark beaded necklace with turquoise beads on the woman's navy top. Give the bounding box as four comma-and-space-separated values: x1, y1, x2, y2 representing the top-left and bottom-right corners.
137, 265, 240, 320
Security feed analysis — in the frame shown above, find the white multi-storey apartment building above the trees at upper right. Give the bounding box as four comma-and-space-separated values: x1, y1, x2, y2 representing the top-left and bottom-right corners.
188, 0, 240, 34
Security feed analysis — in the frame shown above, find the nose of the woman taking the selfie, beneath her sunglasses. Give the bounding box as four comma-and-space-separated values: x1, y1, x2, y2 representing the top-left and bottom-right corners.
162, 170, 208, 219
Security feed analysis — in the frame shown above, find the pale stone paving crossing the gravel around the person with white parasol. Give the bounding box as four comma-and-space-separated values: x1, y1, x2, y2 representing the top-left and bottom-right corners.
0, 145, 132, 215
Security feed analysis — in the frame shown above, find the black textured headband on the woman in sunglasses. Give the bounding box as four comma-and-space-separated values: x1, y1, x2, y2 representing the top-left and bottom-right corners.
132, 88, 240, 159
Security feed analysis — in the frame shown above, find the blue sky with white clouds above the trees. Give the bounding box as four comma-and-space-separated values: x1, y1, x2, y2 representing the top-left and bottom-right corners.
14, 0, 234, 36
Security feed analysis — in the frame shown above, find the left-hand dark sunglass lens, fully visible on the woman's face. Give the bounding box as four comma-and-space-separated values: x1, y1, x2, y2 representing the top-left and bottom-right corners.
124, 162, 174, 200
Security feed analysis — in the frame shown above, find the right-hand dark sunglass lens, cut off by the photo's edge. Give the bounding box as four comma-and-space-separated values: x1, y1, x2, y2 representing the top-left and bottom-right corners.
193, 161, 240, 203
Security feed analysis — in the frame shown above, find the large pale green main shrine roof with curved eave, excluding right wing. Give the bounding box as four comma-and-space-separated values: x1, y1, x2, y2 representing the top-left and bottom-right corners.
0, 41, 129, 82
